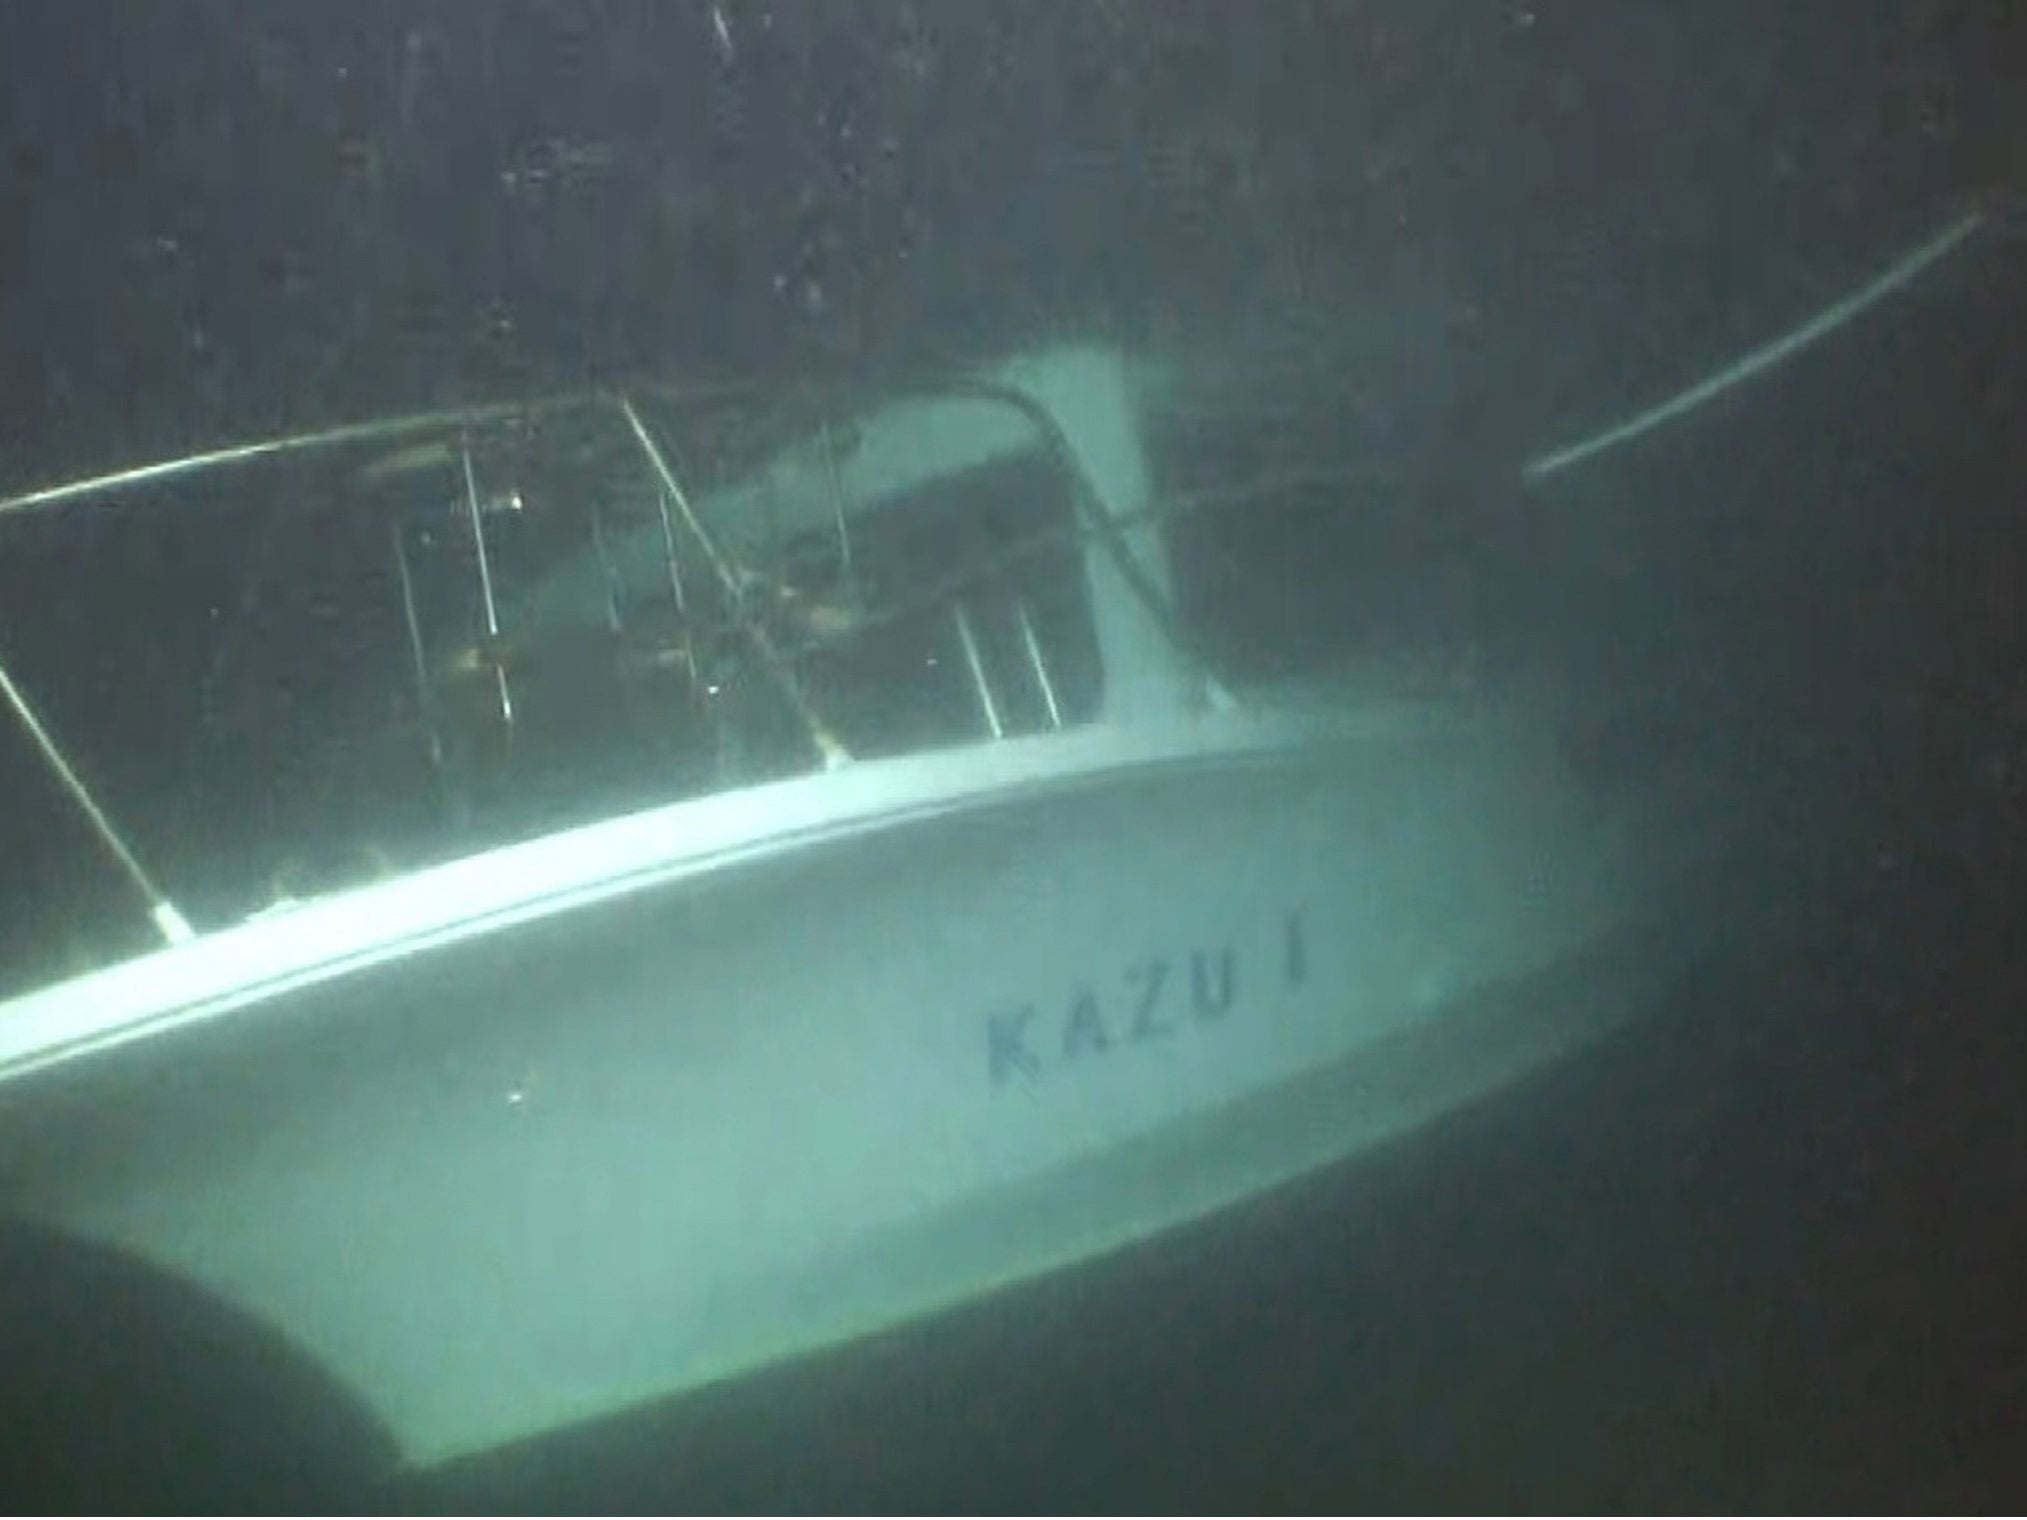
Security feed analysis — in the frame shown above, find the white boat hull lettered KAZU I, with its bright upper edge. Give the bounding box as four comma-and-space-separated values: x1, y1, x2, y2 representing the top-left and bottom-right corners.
0, 693, 1727, 1463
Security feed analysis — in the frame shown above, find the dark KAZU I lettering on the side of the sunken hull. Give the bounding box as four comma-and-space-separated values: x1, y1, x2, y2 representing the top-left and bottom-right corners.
985, 910, 1309, 1088
